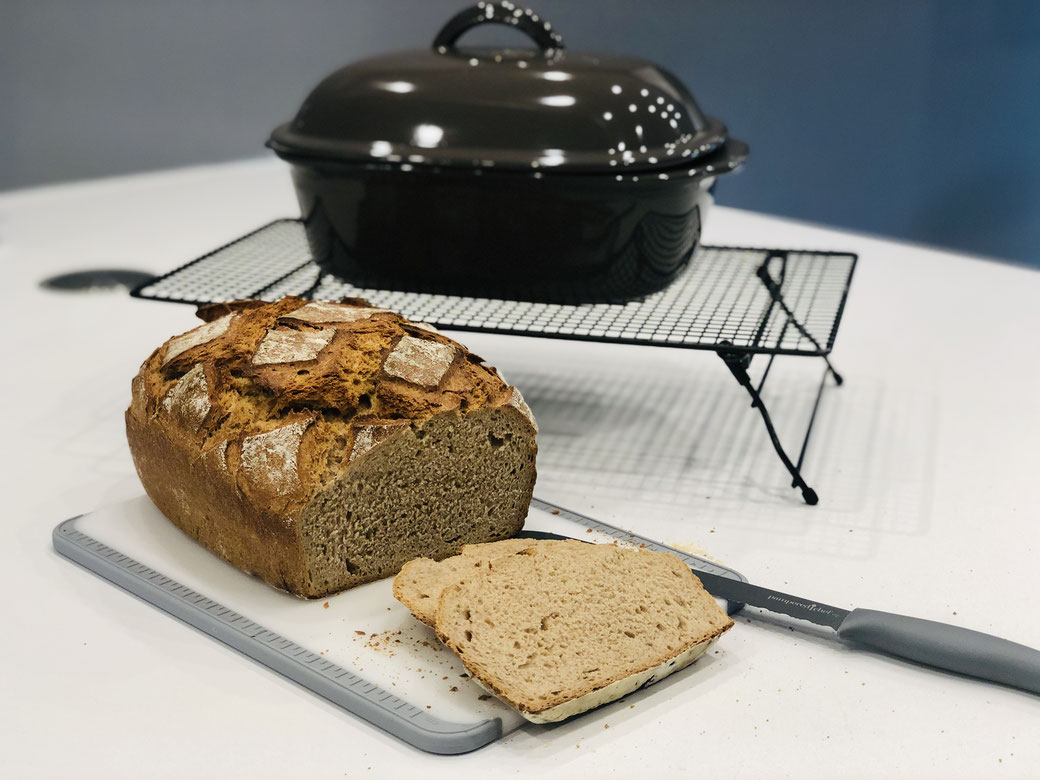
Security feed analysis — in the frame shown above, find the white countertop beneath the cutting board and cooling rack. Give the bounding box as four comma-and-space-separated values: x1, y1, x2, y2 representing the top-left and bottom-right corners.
0, 160, 1040, 778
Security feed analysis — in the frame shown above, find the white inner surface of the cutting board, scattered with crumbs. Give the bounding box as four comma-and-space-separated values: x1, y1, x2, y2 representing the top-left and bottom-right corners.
76, 496, 673, 733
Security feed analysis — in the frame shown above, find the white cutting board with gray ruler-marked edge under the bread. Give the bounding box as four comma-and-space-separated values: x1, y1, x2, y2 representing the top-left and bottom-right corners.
53, 496, 744, 753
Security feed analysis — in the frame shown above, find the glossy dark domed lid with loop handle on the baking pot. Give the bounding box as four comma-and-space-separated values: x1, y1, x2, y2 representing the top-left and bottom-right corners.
268, 2, 726, 173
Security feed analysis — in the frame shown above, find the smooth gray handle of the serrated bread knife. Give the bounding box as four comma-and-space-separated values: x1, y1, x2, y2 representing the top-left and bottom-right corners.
838, 609, 1040, 694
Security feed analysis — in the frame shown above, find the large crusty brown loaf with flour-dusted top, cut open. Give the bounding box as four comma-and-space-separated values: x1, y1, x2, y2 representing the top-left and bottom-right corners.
126, 297, 537, 598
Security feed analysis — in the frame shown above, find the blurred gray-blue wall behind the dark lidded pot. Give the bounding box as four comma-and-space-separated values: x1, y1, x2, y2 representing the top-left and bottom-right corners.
0, 0, 1040, 265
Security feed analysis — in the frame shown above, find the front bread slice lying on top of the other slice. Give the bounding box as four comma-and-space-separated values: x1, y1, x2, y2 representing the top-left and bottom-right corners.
435, 542, 733, 723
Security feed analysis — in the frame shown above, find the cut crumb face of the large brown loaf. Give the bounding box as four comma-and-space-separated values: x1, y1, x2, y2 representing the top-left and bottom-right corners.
298, 408, 534, 592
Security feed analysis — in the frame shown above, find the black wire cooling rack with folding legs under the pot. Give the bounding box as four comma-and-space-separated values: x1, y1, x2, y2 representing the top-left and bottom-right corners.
131, 219, 856, 503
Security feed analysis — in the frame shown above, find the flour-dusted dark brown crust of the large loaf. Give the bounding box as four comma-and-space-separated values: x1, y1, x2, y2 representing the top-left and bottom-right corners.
126, 297, 537, 597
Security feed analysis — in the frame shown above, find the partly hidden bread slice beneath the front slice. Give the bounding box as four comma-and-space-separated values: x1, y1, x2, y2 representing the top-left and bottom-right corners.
393, 539, 535, 626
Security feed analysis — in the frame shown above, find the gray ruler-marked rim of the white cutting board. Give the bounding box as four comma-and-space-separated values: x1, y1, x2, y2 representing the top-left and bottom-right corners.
52, 498, 747, 755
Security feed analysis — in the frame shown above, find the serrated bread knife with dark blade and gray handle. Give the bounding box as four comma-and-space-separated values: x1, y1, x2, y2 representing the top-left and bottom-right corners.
520, 530, 1040, 694
